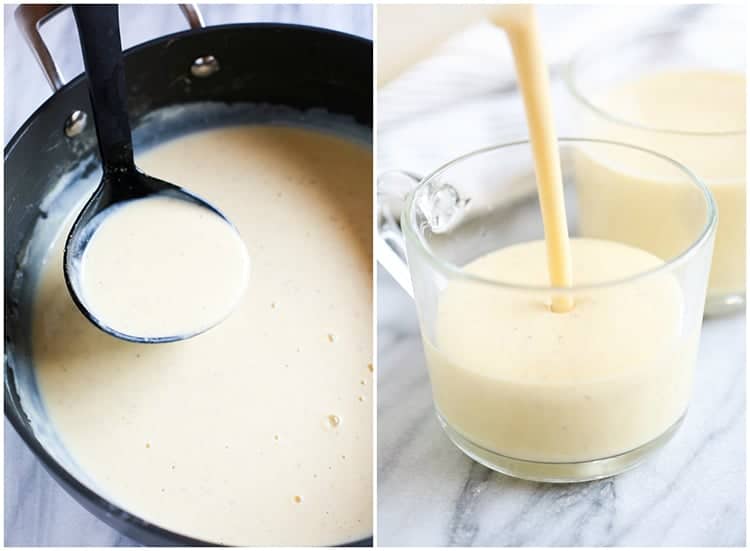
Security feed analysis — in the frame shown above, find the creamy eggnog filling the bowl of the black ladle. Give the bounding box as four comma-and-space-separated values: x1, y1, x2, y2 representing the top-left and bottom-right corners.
81, 194, 250, 338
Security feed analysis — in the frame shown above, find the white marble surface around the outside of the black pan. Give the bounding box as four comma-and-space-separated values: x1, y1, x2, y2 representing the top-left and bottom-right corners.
4, 4, 372, 546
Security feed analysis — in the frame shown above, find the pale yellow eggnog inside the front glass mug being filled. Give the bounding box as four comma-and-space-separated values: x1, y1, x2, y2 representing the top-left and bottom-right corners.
425, 238, 698, 462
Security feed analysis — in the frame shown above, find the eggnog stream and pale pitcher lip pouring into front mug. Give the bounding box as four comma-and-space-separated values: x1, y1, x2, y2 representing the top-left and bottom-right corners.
378, 5, 573, 312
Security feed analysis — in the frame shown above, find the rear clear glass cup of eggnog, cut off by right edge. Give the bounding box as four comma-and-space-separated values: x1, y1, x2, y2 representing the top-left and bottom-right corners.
565, 25, 746, 315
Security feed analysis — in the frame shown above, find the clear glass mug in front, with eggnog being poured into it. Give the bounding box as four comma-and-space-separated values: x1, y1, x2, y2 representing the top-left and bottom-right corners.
377, 139, 716, 482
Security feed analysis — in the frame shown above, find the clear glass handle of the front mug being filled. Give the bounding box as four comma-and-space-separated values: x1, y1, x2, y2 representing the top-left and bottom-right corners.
375, 170, 421, 298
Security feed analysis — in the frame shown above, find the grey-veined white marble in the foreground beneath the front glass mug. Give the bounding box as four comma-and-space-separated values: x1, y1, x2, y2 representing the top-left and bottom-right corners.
378, 269, 745, 546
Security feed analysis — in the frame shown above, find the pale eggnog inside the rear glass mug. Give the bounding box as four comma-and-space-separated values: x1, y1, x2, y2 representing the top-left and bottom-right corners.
578, 70, 746, 298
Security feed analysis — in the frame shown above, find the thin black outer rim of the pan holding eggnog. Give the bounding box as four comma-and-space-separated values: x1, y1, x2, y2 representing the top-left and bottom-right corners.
4, 23, 373, 547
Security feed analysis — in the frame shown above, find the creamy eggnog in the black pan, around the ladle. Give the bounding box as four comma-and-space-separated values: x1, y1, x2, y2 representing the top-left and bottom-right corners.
32, 126, 373, 545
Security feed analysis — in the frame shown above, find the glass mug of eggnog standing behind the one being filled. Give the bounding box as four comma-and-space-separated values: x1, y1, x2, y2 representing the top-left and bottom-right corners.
566, 25, 747, 314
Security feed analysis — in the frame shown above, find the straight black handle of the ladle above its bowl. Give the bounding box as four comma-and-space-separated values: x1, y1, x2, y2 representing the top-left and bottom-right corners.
73, 4, 134, 172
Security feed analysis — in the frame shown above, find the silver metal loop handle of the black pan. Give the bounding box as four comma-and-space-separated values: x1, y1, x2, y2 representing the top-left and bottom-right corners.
15, 4, 205, 92
